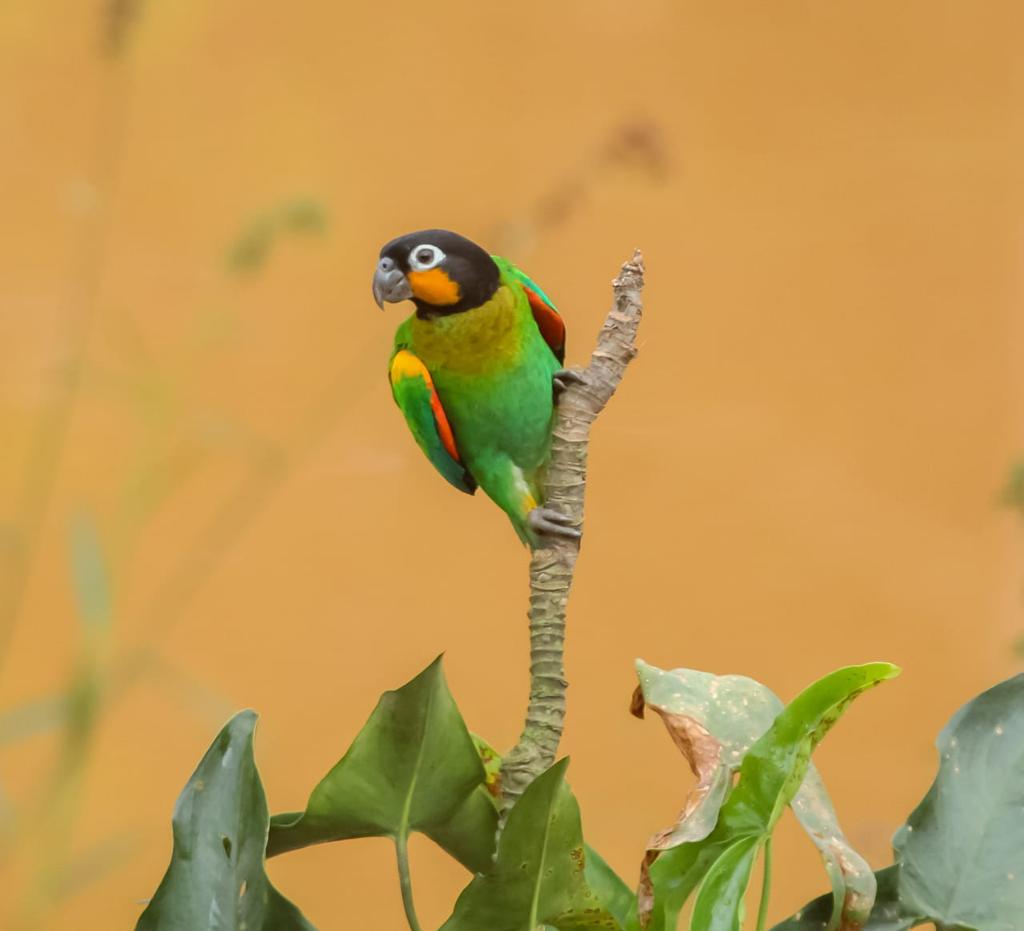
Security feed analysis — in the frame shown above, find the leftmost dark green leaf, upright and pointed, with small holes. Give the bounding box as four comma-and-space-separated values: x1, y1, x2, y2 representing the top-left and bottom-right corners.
135, 711, 313, 931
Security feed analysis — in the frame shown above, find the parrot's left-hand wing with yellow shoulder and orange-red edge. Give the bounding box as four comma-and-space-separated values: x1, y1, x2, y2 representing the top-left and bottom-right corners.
389, 349, 476, 495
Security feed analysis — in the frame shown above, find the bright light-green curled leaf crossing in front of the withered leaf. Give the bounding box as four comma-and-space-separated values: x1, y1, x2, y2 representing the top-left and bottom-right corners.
638, 663, 899, 931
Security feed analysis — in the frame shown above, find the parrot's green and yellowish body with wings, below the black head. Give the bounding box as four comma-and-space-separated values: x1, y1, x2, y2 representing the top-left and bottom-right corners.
391, 257, 561, 545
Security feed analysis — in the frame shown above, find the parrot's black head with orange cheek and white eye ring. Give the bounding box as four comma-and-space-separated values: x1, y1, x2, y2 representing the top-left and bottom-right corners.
374, 229, 500, 316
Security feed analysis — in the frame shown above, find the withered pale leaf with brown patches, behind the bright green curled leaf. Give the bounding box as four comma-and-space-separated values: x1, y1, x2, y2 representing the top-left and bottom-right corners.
633, 661, 888, 928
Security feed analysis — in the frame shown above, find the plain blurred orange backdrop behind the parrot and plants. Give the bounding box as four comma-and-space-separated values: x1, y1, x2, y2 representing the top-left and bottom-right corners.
0, 0, 1024, 929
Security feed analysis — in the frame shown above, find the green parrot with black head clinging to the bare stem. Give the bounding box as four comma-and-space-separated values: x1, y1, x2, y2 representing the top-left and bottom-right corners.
373, 229, 583, 549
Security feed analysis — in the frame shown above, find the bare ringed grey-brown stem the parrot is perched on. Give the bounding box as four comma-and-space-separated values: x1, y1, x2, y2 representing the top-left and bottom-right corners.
501, 251, 644, 819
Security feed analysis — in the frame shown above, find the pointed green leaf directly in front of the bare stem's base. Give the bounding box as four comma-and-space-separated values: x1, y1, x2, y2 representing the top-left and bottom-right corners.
441, 760, 618, 931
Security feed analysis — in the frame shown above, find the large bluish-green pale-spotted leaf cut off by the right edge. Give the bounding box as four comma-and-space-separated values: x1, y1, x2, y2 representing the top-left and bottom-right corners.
893, 674, 1024, 931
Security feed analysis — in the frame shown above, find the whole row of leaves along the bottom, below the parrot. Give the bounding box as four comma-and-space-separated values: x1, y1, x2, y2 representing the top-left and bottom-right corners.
137, 659, 1024, 931
